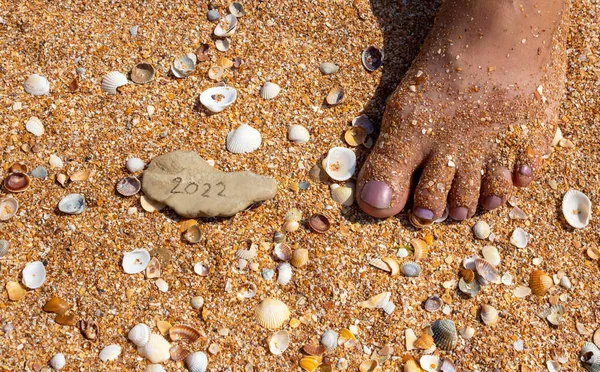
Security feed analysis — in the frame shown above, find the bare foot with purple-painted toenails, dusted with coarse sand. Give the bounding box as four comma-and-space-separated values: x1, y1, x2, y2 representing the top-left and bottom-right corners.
357, 0, 569, 221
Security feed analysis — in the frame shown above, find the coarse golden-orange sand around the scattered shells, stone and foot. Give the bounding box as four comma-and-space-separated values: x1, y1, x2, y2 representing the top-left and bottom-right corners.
0, 0, 600, 372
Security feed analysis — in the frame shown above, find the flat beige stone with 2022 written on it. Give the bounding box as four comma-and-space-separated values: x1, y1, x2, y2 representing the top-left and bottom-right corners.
142, 151, 277, 218
